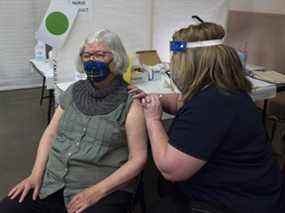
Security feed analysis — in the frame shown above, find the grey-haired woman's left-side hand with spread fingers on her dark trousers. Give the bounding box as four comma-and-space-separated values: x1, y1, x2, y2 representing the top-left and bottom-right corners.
8, 176, 42, 203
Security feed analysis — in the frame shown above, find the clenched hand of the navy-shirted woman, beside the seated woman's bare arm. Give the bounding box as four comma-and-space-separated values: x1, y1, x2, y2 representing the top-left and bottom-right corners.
142, 95, 162, 122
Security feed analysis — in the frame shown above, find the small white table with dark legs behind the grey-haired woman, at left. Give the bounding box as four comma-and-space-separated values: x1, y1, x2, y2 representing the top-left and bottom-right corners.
30, 59, 54, 123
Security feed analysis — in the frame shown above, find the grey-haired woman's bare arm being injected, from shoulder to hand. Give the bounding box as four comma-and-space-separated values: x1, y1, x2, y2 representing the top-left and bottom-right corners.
68, 100, 147, 212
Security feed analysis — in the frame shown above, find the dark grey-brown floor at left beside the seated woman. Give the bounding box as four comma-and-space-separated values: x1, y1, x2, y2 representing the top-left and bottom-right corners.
0, 88, 48, 198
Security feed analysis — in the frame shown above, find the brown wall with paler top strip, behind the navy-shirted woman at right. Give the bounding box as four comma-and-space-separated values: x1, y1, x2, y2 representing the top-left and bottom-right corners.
227, 0, 285, 73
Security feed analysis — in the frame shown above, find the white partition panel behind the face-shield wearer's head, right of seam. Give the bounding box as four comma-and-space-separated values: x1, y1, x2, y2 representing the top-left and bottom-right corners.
153, 0, 229, 61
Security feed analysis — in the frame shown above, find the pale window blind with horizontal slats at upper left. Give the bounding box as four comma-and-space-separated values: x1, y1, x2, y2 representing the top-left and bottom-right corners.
0, 0, 46, 90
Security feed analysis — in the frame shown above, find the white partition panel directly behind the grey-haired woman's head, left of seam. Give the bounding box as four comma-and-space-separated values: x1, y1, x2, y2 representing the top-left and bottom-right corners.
57, 0, 151, 82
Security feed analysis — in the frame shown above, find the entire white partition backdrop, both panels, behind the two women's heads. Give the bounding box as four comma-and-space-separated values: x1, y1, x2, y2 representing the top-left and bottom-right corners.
57, 0, 228, 82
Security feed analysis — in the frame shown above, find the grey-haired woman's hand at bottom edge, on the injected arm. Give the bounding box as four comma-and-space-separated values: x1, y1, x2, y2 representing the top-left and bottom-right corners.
67, 187, 104, 213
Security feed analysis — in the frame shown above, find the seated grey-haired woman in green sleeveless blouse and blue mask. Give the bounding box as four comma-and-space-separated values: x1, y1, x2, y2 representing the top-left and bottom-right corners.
0, 30, 147, 213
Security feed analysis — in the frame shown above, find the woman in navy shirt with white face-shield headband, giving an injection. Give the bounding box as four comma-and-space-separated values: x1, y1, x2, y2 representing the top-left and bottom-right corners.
131, 22, 285, 213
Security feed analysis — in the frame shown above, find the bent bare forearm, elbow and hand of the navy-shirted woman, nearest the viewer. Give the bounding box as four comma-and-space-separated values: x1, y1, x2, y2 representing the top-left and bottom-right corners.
144, 95, 206, 181
